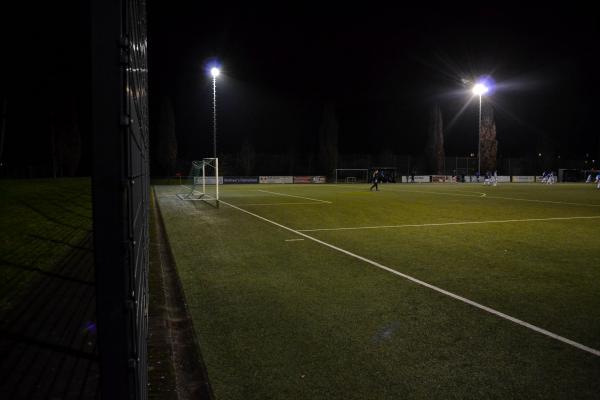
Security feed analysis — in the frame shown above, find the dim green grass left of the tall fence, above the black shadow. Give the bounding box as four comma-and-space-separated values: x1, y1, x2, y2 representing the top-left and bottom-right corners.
0, 178, 92, 314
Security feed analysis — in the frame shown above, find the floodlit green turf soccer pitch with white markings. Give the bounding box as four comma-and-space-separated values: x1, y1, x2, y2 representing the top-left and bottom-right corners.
155, 184, 600, 399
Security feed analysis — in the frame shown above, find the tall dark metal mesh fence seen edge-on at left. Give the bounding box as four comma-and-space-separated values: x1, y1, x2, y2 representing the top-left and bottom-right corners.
91, 0, 150, 399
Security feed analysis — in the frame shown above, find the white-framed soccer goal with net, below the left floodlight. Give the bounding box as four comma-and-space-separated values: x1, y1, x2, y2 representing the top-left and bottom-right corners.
177, 158, 222, 206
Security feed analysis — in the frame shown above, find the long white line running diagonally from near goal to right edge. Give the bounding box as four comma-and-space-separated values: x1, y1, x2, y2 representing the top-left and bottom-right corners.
221, 201, 600, 357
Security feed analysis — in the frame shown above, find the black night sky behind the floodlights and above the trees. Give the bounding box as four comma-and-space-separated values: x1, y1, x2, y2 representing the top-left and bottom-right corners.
0, 1, 600, 174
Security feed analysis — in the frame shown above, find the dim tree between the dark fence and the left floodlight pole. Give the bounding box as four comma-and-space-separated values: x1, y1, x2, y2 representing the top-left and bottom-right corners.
157, 97, 177, 176
